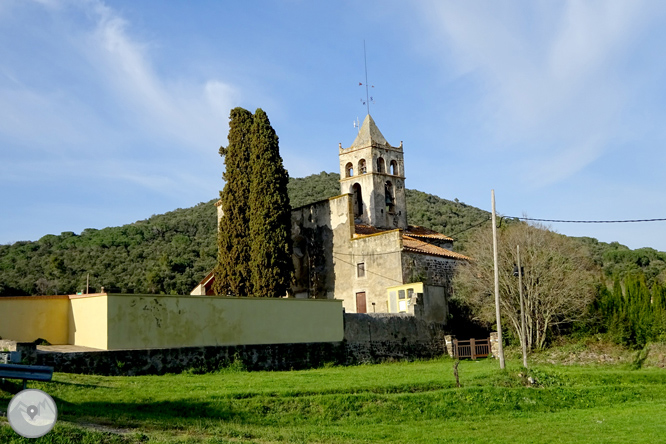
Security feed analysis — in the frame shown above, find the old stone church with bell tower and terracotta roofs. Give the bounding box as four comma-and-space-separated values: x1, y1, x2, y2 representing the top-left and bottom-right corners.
192, 115, 468, 323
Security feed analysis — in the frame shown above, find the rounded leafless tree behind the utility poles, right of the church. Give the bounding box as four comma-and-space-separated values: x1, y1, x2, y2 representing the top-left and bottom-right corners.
454, 223, 598, 350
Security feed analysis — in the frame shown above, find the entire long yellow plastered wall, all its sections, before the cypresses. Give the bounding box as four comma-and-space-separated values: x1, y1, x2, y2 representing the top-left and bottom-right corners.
0, 294, 343, 350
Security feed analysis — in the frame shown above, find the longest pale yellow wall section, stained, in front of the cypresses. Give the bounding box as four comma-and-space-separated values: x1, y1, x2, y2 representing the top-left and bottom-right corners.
108, 294, 344, 350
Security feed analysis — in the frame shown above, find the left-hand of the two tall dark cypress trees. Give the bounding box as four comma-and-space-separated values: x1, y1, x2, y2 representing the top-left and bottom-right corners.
213, 108, 253, 296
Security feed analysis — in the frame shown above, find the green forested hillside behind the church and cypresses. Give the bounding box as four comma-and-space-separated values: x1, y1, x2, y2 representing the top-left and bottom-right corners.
0, 172, 666, 295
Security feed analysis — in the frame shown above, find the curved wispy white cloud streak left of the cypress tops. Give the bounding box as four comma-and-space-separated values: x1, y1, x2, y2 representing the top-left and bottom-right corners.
85, 2, 239, 149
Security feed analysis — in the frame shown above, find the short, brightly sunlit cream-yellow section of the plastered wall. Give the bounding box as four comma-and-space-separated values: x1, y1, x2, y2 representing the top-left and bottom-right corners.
68, 294, 109, 350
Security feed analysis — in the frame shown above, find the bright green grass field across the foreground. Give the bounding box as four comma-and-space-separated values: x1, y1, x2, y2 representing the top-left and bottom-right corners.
0, 358, 666, 444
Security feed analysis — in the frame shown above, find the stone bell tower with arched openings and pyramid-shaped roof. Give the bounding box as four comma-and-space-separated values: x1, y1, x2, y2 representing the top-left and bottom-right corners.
340, 114, 407, 228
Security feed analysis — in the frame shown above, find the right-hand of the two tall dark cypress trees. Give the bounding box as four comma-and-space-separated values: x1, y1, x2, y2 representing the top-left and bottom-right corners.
250, 108, 293, 297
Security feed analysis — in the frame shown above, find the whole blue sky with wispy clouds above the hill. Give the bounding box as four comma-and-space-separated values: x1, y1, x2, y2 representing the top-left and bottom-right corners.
0, 0, 666, 251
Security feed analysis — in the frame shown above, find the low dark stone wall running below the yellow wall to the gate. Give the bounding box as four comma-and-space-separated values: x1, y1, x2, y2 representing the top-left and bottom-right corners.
29, 312, 447, 376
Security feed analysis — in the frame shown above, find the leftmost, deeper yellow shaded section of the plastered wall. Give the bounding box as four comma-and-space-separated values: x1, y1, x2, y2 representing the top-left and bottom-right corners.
0, 296, 69, 345
